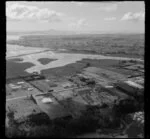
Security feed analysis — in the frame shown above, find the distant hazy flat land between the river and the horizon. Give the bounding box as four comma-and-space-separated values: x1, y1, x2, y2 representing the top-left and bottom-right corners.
7, 34, 144, 57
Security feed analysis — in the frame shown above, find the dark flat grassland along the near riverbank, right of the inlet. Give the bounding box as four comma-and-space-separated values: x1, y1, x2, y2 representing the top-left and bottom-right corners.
42, 59, 141, 77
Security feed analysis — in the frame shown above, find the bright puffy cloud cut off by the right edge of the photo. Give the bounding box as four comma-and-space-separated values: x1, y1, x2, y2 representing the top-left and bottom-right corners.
121, 11, 145, 21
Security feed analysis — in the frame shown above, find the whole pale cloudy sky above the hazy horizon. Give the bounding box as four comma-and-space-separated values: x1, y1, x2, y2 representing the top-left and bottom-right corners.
6, 1, 145, 33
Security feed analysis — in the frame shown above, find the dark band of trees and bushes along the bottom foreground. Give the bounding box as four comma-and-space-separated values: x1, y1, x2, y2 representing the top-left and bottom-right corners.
6, 95, 144, 138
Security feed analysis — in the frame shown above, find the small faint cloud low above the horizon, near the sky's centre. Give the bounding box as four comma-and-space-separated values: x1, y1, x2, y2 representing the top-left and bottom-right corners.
69, 18, 88, 29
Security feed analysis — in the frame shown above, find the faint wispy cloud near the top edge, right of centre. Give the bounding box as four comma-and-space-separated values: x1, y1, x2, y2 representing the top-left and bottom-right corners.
98, 4, 118, 12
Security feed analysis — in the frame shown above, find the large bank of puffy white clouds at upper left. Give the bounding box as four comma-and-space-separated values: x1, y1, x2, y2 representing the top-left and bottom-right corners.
6, 3, 63, 22
